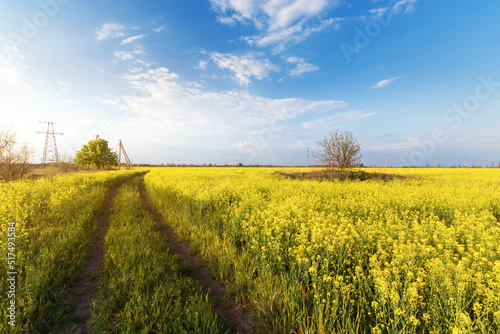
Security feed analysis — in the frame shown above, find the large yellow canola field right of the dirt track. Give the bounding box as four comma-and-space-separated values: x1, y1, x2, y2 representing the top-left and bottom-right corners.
145, 168, 500, 333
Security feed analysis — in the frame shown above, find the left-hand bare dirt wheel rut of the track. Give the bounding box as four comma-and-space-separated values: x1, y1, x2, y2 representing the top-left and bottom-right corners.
65, 187, 118, 334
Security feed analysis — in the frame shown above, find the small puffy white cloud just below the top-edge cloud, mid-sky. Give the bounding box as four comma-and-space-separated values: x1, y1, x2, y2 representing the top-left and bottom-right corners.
210, 52, 279, 86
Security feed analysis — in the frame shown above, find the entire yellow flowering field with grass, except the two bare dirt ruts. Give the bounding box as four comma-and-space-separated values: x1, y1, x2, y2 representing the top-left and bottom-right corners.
0, 168, 500, 333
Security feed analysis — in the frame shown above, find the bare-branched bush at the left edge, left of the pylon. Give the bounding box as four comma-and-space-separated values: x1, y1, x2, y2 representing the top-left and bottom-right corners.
0, 129, 33, 180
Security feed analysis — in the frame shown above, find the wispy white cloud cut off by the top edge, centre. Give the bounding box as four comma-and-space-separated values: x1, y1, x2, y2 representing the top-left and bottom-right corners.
210, 0, 339, 53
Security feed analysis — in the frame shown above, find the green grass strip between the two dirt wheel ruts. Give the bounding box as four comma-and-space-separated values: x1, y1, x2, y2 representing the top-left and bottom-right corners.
90, 177, 229, 333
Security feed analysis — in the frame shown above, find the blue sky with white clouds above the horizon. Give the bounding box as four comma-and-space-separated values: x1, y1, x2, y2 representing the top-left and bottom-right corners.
0, 0, 500, 166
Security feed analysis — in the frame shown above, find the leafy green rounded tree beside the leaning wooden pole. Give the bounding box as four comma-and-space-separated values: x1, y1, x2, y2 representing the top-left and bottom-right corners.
75, 139, 118, 169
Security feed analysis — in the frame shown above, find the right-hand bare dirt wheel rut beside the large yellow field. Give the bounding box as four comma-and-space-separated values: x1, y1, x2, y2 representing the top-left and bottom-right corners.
139, 183, 260, 334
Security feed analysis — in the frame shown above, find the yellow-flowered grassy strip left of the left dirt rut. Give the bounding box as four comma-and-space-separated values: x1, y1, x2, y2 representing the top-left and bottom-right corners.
0, 173, 141, 333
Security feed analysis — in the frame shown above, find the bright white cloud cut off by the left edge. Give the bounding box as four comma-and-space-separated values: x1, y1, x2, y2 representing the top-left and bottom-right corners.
0, 45, 32, 90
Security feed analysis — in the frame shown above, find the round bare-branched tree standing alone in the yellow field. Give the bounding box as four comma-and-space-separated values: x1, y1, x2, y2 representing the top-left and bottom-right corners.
313, 130, 361, 170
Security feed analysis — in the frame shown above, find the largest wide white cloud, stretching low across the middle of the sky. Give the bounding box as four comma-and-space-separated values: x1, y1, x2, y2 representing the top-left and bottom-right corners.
102, 67, 346, 136
